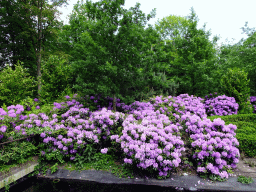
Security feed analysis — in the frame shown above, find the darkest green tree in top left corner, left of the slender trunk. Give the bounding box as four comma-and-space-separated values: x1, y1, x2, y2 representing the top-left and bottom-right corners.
0, 0, 36, 74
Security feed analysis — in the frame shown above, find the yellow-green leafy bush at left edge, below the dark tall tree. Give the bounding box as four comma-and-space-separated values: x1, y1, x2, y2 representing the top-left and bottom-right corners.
0, 61, 37, 106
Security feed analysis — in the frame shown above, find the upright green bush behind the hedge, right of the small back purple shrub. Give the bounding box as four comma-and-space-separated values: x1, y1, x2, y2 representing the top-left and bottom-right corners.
220, 68, 253, 114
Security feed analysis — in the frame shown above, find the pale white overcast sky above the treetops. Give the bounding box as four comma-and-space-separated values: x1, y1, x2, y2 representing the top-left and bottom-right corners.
54, 0, 256, 51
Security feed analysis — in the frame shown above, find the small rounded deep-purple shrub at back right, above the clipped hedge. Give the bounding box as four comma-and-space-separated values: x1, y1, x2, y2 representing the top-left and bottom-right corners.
204, 95, 239, 116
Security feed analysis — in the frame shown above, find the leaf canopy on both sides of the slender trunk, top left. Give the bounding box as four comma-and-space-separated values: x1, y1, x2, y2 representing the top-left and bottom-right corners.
0, 0, 67, 78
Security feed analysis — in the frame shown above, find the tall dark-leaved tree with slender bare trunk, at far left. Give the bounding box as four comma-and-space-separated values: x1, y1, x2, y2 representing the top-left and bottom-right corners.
0, 0, 70, 98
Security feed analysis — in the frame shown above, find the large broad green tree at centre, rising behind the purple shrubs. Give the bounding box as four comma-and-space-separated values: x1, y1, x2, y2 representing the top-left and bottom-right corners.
60, 0, 178, 110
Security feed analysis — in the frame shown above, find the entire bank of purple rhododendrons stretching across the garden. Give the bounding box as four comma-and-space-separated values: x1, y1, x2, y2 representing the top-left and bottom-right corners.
0, 94, 244, 179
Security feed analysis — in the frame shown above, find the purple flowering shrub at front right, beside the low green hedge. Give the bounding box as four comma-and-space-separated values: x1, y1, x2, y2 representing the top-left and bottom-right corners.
181, 113, 240, 179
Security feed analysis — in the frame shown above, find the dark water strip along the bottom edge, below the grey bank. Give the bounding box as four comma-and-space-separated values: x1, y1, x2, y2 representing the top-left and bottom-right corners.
0, 176, 198, 192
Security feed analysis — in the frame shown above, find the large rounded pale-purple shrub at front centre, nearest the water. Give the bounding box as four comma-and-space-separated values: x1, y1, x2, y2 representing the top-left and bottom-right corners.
111, 102, 185, 176
